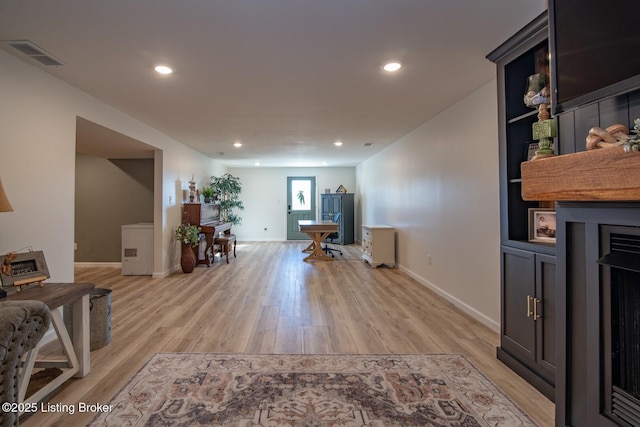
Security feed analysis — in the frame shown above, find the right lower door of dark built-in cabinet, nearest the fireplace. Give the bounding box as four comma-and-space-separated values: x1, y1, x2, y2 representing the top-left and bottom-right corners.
535, 254, 556, 384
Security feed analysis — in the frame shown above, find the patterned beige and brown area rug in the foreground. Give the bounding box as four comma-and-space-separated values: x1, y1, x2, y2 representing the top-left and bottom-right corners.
90, 353, 536, 427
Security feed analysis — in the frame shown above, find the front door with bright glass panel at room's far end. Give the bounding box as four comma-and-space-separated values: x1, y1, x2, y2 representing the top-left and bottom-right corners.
287, 176, 316, 240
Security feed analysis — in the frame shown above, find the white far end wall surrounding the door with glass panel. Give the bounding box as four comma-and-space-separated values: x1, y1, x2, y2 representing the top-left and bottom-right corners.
229, 167, 358, 241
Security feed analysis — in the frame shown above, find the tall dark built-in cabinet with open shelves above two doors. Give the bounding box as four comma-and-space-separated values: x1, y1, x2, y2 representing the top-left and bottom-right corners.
487, 12, 557, 400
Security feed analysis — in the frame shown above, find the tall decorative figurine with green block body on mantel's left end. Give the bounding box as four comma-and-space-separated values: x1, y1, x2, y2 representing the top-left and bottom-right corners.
524, 73, 556, 160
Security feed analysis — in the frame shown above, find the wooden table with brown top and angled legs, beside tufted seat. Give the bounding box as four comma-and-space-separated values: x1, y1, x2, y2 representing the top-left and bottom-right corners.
7, 283, 95, 410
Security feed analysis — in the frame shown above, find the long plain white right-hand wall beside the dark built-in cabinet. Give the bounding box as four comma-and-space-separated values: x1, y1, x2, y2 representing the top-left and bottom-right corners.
357, 80, 500, 330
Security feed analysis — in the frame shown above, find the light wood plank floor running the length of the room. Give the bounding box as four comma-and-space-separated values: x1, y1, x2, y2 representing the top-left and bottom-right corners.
21, 242, 555, 427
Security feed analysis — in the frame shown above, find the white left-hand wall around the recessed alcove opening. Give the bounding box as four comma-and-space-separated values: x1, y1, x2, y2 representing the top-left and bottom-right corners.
0, 51, 224, 282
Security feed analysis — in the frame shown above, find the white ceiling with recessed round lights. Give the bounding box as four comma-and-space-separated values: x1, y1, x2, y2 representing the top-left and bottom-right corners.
0, 0, 546, 166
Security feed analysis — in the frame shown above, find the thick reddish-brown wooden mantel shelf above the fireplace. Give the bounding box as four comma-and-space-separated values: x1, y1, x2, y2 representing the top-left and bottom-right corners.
520, 147, 640, 201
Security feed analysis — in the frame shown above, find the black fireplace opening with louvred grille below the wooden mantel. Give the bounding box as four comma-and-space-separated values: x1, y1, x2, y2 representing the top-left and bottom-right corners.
599, 229, 640, 426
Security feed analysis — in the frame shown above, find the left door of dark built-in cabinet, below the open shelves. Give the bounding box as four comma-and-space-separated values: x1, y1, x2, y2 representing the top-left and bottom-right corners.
501, 247, 536, 365
